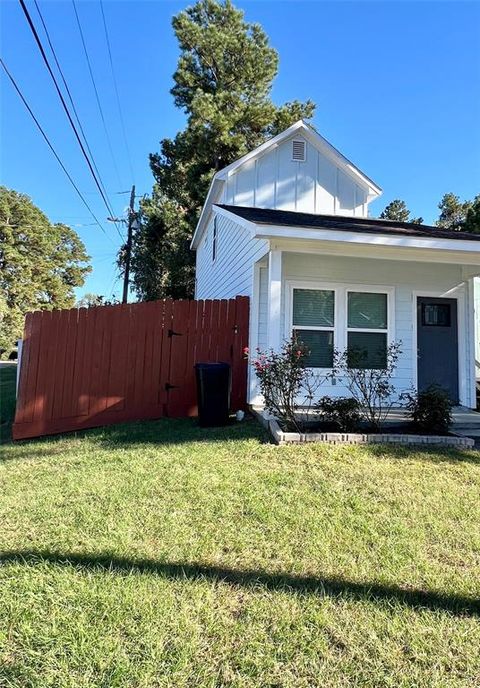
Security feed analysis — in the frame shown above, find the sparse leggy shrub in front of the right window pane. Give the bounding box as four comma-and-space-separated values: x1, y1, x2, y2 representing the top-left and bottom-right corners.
330, 342, 401, 431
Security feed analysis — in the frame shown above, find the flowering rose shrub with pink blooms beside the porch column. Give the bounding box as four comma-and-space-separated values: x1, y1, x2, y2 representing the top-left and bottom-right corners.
245, 337, 320, 432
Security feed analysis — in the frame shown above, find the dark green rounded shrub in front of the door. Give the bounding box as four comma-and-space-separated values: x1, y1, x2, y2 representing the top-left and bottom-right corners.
402, 385, 453, 435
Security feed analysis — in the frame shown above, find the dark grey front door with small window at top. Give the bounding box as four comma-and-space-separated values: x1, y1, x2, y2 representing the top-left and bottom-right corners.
417, 296, 458, 403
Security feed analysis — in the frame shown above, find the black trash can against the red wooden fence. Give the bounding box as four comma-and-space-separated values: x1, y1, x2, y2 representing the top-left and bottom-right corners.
195, 363, 231, 428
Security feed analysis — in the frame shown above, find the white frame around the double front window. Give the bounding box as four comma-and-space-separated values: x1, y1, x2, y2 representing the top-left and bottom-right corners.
285, 280, 396, 370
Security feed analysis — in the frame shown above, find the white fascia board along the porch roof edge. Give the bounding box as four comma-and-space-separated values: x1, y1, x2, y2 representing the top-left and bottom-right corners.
255, 224, 480, 265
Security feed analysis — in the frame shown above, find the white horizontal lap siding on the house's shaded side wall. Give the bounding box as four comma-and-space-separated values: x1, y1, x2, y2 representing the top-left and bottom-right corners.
195, 215, 267, 299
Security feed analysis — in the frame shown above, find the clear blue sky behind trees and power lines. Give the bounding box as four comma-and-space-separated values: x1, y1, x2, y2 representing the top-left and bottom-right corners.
0, 0, 480, 296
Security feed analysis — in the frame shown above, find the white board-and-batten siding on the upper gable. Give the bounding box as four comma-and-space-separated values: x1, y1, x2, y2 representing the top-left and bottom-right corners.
222, 136, 368, 217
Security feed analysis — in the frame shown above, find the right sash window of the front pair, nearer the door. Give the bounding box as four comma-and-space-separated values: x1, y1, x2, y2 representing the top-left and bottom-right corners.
347, 291, 388, 369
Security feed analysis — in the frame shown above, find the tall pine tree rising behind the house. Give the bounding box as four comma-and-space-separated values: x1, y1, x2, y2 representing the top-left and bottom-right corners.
132, 0, 315, 300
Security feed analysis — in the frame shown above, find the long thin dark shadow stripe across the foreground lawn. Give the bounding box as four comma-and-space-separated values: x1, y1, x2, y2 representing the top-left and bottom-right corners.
0, 550, 480, 616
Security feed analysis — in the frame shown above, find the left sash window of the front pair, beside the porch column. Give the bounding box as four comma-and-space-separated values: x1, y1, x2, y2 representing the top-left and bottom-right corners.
292, 289, 335, 368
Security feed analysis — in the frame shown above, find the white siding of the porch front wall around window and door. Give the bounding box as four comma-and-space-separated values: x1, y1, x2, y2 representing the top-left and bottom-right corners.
253, 252, 468, 404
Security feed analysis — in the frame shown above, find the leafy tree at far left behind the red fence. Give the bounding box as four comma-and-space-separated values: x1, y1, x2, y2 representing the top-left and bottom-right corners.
0, 186, 91, 350
